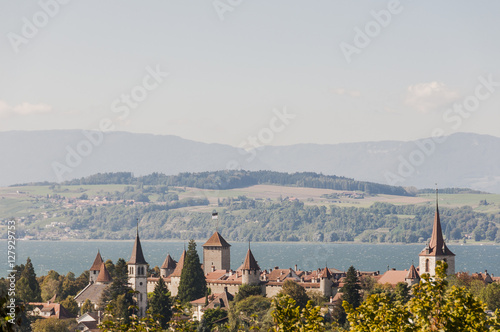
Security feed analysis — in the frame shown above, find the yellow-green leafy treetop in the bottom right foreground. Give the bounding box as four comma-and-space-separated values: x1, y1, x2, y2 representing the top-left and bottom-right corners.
343, 261, 500, 332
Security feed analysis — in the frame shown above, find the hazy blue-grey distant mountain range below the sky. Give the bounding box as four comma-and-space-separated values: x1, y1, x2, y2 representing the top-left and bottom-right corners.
0, 130, 500, 193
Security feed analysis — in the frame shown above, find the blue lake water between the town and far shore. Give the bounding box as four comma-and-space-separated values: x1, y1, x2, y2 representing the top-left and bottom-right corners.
0, 240, 500, 277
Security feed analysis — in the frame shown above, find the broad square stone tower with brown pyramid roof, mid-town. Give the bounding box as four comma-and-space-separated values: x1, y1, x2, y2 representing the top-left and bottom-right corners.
203, 232, 231, 275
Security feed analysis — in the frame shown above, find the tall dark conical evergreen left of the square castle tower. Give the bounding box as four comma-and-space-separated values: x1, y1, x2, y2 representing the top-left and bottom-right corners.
177, 240, 207, 303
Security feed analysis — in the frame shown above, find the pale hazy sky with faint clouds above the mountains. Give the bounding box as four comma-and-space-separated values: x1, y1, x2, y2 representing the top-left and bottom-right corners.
0, 0, 500, 146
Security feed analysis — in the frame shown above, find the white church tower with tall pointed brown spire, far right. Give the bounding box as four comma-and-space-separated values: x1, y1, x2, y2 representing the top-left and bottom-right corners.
418, 189, 455, 277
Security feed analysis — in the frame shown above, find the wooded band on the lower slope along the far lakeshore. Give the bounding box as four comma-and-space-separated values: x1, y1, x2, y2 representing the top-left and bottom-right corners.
48, 196, 500, 243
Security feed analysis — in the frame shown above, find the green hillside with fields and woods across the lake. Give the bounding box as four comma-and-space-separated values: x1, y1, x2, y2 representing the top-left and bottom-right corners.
0, 172, 500, 243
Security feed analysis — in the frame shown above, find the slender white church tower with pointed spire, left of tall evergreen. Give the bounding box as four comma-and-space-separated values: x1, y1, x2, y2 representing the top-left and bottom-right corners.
127, 229, 148, 317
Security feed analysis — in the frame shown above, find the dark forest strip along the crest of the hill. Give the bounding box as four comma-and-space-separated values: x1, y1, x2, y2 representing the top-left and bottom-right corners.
57, 170, 414, 196
